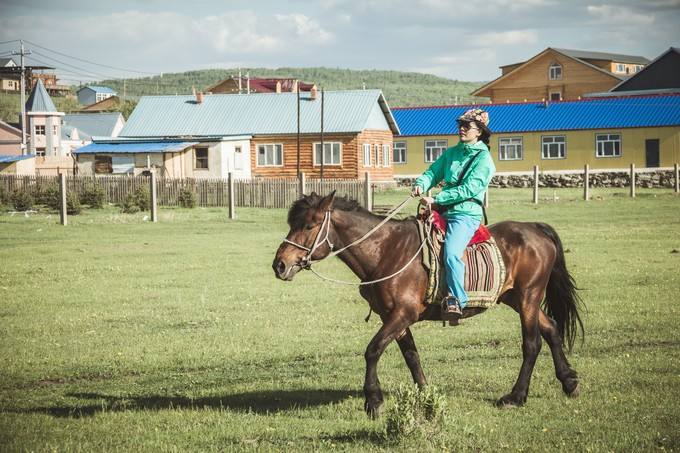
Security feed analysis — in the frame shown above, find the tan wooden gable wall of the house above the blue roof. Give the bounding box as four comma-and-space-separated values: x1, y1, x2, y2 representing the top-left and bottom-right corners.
480, 52, 620, 103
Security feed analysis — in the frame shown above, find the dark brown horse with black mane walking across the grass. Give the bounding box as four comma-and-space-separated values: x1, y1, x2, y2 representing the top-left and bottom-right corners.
272, 192, 583, 417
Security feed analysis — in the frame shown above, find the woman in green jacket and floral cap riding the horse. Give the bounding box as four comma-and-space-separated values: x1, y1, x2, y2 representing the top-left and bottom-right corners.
412, 109, 496, 319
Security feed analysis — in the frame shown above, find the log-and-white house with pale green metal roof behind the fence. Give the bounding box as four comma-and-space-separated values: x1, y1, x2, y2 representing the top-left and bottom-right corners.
74, 90, 399, 181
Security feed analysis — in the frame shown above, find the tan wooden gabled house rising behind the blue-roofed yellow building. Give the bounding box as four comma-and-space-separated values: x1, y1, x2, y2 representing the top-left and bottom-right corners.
472, 47, 649, 103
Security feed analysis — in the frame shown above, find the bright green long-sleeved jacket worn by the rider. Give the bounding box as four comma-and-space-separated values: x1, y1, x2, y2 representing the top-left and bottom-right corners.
415, 141, 496, 220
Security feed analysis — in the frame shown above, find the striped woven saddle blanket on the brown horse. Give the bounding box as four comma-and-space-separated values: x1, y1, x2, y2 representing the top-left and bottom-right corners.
421, 220, 506, 308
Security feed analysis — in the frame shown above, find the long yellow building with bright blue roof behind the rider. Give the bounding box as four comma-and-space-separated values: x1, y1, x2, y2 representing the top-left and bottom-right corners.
393, 94, 680, 178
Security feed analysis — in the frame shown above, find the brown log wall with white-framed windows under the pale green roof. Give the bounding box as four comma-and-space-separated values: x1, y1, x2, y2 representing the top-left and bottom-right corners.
250, 130, 393, 181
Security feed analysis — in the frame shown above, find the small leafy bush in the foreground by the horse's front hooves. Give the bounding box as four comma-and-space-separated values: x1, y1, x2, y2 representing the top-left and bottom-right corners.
385, 386, 446, 440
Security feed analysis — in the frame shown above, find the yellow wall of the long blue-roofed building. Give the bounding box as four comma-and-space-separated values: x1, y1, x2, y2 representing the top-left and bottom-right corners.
394, 126, 680, 176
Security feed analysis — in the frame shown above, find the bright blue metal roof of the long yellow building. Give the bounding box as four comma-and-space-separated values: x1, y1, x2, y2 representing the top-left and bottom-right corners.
393, 95, 680, 136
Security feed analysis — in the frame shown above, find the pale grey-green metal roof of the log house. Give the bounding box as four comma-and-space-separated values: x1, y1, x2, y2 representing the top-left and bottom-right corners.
120, 90, 399, 137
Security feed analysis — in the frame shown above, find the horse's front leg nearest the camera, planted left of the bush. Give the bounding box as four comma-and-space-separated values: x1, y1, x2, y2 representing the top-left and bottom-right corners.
364, 312, 413, 418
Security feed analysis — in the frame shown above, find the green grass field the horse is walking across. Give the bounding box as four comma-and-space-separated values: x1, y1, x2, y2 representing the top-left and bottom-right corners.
0, 189, 680, 451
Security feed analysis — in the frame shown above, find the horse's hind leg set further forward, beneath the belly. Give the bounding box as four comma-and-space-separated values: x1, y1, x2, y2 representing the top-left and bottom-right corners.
496, 289, 544, 407
